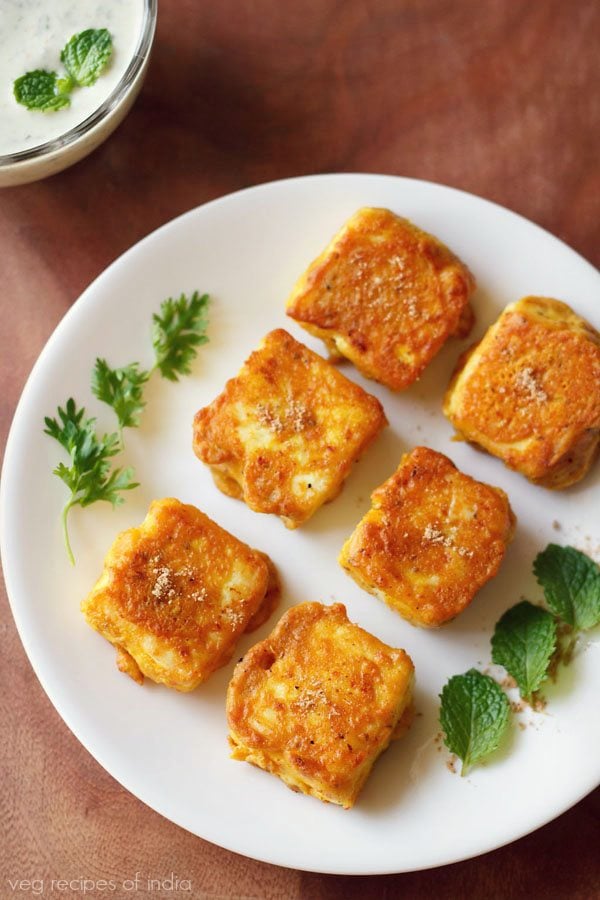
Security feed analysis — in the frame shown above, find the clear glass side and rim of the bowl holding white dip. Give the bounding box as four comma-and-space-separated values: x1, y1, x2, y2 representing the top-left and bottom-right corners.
0, 0, 157, 187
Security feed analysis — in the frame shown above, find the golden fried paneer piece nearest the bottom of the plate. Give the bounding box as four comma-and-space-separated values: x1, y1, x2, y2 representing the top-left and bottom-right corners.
227, 603, 414, 809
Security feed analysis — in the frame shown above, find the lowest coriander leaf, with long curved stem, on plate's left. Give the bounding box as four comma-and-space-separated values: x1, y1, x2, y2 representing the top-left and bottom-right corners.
44, 398, 137, 564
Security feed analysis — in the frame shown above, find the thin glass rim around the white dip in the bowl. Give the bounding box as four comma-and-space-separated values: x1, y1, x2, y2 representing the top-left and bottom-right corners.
0, 0, 158, 169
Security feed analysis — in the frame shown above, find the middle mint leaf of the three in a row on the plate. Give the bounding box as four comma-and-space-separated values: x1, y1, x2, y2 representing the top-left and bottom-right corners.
492, 600, 556, 699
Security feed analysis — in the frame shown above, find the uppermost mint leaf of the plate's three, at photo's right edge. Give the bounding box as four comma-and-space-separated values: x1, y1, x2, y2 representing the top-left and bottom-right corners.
533, 544, 600, 630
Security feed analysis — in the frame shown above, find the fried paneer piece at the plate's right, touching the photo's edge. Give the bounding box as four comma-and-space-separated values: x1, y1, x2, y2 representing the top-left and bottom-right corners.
444, 297, 600, 489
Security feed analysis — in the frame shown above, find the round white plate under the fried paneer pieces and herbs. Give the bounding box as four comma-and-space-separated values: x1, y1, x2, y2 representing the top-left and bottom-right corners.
1, 175, 600, 874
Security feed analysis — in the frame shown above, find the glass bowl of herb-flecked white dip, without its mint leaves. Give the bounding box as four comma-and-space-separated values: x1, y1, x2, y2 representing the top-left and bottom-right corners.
0, 0, 156, 186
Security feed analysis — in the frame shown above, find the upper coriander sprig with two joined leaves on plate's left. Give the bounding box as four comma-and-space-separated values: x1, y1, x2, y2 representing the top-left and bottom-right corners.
92, 291, 210, 436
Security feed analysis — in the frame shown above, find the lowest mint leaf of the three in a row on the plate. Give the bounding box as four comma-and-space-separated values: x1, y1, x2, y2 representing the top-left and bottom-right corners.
440, 669, 510, 775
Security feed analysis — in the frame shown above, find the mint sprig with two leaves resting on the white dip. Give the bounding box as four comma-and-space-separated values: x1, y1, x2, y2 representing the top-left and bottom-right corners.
13, 28, 112, 112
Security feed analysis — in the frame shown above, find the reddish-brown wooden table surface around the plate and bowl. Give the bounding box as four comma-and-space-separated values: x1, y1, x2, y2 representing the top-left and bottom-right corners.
0, 0, 600, 900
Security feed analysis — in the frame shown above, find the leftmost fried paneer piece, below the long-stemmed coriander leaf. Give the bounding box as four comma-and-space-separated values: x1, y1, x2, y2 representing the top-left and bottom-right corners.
81, 498, 279, 691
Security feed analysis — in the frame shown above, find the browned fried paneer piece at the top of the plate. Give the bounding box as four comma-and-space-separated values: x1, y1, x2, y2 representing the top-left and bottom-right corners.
287, 207, 475, 391
